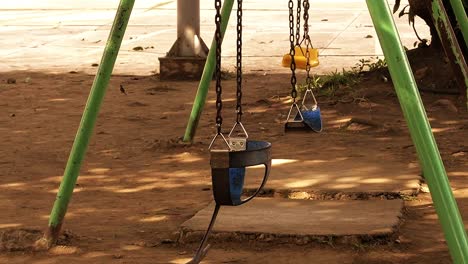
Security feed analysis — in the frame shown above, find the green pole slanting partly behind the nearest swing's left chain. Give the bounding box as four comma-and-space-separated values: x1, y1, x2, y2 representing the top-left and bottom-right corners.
184, 0, 234, 142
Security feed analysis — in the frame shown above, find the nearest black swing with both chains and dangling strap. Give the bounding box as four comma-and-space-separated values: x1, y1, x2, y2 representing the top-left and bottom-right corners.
188, 0, 271, 264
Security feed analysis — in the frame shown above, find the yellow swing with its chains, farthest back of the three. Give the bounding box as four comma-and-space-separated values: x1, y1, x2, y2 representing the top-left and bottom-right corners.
281, 0, 320, 70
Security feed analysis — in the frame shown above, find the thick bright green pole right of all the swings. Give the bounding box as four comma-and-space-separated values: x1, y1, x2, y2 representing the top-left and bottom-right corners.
367, 0, 468, 264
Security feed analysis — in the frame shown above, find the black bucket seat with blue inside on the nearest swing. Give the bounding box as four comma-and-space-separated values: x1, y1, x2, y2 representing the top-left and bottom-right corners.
210, 140, 271, 206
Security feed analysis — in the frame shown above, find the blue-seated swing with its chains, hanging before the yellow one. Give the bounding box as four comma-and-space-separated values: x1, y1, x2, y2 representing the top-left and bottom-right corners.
285, 0, 322, 132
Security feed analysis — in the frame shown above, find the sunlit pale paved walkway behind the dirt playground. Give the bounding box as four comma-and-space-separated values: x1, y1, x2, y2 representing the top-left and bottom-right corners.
0, 0, 429, 75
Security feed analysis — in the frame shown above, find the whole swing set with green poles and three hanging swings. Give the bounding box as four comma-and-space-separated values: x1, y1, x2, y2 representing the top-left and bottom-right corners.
38, 0, 468, 263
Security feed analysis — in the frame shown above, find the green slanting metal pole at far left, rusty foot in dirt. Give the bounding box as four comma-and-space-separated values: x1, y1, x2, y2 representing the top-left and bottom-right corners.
37, 0, 135, 248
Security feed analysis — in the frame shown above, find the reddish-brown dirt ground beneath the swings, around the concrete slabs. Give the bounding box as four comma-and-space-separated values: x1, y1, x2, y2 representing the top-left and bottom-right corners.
0, 68, 468, 264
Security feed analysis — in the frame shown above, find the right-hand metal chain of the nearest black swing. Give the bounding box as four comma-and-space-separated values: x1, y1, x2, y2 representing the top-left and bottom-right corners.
236, 0, 242, 123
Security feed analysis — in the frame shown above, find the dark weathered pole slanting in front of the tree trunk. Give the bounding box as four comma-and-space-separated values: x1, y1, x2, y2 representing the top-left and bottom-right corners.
431, 0, 468, 106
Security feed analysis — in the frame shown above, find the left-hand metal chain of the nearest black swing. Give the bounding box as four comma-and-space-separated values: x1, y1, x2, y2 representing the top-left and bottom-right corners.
215, 0, 223, 135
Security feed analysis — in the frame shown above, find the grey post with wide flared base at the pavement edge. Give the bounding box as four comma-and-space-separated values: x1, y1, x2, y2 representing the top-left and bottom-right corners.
159, 0, 208, 80
